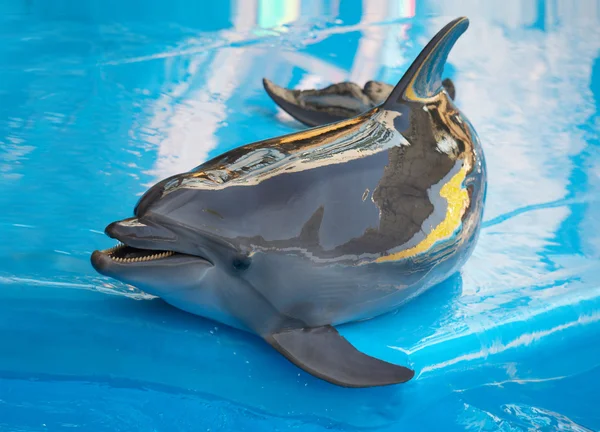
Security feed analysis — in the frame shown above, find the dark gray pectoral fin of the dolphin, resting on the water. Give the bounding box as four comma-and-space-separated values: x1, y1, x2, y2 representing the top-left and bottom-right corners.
265, 326, 414, 387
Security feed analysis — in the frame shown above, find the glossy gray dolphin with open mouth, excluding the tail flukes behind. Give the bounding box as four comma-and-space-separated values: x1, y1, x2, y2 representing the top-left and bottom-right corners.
91, 18, 487, 387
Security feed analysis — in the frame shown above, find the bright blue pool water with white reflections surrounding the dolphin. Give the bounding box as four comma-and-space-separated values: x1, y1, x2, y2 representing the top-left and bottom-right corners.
0, 0, 600, 432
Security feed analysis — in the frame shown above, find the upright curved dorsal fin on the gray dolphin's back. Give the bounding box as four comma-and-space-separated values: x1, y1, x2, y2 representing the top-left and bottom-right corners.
383, 17, 469, 110
